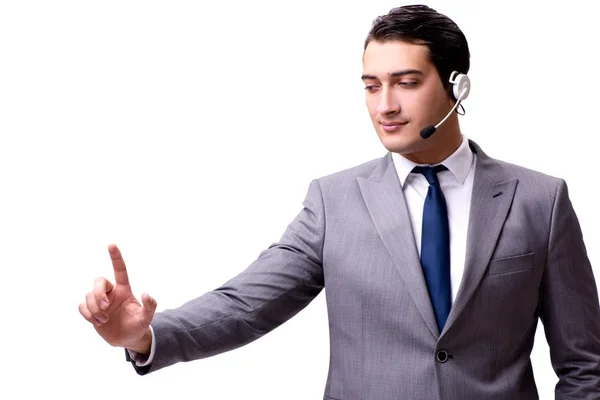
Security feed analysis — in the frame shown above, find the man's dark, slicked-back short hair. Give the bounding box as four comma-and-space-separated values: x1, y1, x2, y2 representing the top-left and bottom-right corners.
364, 5, 470, 94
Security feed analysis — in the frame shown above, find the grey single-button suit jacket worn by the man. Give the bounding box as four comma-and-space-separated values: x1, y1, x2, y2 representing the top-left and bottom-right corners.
130, 142, 600, 400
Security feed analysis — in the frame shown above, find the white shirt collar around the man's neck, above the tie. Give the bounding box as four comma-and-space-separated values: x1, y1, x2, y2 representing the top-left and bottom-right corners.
392, 136, 473, 187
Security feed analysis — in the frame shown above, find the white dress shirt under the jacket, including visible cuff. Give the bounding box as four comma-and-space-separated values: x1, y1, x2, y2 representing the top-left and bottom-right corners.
128, 136, 476, 367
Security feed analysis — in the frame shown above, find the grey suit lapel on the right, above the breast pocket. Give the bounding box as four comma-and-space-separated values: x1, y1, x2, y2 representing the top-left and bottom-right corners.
442, 141, 517, 336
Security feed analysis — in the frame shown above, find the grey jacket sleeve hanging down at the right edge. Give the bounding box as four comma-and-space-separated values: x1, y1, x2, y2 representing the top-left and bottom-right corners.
540, 180, 600, 400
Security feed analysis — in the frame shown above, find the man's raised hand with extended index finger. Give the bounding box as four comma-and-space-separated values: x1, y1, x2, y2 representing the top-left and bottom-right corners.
79, 245, 156, 354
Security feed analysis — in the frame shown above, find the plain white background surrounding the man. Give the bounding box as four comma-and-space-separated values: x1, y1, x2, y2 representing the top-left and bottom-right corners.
0, 0, 600, 400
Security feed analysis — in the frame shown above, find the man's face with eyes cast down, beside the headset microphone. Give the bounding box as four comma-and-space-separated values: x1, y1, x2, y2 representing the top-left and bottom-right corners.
362, 41, 453, 162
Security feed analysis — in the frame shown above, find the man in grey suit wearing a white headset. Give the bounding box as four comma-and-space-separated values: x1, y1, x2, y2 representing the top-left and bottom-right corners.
80, 6, 600, 400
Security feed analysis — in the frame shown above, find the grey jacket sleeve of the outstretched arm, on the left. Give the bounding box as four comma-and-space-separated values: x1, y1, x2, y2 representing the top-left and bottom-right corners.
127, 180, 325, 375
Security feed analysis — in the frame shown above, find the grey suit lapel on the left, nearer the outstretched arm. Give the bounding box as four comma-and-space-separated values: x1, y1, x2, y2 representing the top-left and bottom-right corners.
357, 154, 439, 339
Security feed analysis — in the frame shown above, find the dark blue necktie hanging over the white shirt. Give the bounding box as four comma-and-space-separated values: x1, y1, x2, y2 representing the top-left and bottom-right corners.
413, 165, 452, 332
